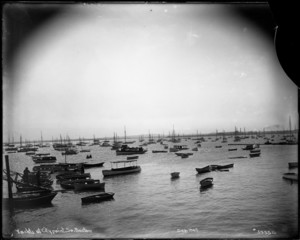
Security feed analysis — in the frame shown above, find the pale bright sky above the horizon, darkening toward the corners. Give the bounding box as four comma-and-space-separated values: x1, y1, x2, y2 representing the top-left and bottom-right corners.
3, 4, 298, 140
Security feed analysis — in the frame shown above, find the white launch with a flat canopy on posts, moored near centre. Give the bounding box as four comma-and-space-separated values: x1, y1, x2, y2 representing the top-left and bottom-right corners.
102, 160, 141, 177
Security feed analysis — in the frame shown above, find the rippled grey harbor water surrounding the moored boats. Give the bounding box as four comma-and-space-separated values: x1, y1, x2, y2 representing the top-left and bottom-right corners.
2, 138, 298, 238
